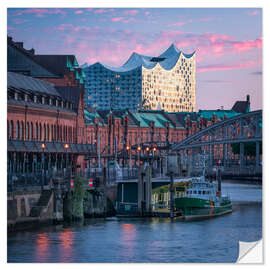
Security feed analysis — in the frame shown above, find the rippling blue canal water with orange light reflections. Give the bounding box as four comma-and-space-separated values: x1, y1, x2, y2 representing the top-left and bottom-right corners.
8, 180, 262, 263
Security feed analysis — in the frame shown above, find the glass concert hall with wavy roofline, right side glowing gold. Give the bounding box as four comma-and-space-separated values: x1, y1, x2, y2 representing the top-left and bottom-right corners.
84, 44, 196, 112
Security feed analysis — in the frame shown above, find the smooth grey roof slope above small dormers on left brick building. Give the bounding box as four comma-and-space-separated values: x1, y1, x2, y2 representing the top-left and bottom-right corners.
7, 72, 60, 97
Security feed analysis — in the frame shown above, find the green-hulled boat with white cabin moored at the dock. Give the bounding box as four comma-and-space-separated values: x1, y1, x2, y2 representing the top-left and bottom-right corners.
175, 159, 232, 220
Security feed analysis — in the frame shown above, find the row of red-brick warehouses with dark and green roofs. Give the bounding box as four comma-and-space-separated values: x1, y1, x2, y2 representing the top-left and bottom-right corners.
7, 37, 250, 172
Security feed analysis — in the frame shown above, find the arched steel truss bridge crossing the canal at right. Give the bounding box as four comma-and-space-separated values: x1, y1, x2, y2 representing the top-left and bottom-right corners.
171, 110, 262, 174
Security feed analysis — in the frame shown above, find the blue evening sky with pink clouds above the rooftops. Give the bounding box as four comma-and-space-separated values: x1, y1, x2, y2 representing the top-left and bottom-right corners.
7, 8, 263, 110
